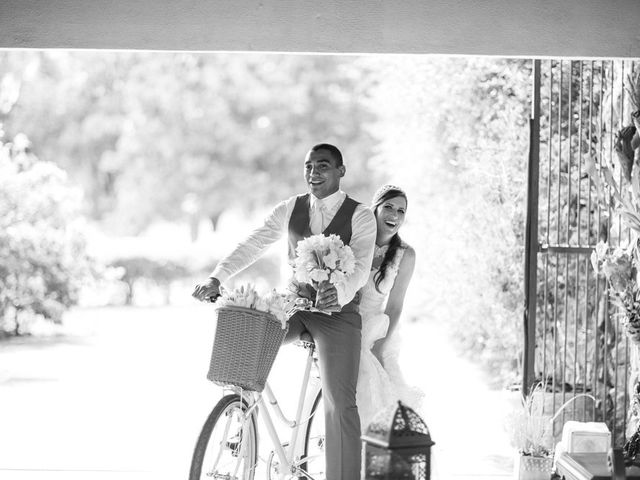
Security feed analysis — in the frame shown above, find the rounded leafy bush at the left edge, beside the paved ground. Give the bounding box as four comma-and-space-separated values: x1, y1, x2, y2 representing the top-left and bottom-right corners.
0, 131, 91, 335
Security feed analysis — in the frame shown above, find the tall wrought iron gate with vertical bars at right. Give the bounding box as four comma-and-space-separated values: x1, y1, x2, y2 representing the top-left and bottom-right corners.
523, 60, 638, 445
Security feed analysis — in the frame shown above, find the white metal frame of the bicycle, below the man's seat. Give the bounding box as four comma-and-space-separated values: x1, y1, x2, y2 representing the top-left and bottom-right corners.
230, 342, 321, 480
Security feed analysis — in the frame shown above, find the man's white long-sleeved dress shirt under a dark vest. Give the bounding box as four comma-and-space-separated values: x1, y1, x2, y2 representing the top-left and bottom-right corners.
211, 190, 376, 307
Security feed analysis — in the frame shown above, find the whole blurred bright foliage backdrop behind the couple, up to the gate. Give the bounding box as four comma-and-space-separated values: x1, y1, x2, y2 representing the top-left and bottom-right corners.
0, 51, 531, 385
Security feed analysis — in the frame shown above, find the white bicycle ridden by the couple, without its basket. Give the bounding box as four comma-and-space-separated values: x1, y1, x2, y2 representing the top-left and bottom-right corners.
189, 332, 325, 480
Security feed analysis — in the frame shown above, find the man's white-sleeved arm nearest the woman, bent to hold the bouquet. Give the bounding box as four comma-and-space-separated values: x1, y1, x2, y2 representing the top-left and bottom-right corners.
336, 205, 376, 307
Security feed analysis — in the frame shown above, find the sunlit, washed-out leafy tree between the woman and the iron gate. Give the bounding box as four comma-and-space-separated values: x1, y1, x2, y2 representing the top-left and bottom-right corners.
366, 57, 530, 385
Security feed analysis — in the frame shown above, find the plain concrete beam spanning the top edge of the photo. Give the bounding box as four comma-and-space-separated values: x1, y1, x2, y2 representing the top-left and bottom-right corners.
0, 0, 640, 57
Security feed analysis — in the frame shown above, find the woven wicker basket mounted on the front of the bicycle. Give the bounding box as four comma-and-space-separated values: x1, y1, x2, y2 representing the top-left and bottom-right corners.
207, 307, 287, 392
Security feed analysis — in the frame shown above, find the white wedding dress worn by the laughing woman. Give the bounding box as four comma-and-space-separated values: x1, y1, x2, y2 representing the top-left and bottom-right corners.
356, 245, 424, 433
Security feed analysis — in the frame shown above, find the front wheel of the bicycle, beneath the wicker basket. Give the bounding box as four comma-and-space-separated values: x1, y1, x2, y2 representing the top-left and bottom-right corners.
189, 394, 258, 480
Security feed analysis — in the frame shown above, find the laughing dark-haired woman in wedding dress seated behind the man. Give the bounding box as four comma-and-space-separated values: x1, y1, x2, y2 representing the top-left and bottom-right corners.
357, 185, 423, 432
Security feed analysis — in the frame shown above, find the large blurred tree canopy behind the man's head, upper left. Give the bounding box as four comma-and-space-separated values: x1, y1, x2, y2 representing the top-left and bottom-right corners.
0, 52, 374, 233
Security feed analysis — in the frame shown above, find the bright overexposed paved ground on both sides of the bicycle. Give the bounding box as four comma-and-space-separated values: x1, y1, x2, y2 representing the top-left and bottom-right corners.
0, 305, 513, 480
